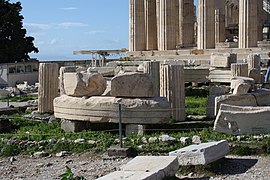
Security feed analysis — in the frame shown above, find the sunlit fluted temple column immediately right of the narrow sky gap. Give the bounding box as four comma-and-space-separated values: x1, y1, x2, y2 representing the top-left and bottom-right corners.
197, 0, 215, 49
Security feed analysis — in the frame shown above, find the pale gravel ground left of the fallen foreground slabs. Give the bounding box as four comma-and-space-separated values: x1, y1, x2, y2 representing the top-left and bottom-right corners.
0, 155, 129, 180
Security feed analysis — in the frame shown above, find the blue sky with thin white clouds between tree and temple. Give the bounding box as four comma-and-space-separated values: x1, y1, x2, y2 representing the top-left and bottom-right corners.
10, 0, 196, 61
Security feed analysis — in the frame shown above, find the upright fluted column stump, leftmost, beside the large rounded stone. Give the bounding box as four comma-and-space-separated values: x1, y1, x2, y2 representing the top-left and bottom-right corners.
38, 63, 59, 113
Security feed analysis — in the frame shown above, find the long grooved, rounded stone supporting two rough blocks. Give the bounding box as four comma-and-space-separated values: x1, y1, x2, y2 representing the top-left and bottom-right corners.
54, 96, 170, 124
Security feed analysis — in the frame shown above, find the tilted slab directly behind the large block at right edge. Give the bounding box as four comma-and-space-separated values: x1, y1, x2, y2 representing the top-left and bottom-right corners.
215, 93, 257, 115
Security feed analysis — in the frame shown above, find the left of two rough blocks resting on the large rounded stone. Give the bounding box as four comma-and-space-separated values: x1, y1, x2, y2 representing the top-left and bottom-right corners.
64, 72, 106, 97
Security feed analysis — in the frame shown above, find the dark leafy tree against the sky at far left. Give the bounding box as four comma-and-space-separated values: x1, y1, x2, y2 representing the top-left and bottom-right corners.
0, 0, 38, 63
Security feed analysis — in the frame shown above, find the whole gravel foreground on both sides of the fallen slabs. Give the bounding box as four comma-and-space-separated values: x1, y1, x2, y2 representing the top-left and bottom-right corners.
0, 155, 270, 180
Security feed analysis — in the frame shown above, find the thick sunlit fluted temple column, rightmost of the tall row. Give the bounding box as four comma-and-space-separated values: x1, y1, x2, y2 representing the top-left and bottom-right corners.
239, 0, 258, 48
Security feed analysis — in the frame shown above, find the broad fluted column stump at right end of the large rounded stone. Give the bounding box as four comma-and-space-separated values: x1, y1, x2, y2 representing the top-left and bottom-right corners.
160, 64, 185, 121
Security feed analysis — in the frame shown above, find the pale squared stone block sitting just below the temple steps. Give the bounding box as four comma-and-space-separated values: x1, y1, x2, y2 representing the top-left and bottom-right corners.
211, 53, 237, 68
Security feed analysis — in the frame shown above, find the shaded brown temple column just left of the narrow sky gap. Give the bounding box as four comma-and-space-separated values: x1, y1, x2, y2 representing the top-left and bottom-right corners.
178, 0, 196, 47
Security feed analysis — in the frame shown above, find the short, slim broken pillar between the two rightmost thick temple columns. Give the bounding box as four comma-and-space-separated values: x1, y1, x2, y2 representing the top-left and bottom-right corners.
215, 0, 226, 43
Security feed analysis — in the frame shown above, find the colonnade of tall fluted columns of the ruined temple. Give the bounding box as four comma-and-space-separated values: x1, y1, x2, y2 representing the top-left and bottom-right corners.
129, 0, 270, 52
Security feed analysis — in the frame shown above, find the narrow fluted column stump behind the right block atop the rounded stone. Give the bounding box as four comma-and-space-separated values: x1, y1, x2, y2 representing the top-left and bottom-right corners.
144, 61, 160, 97
